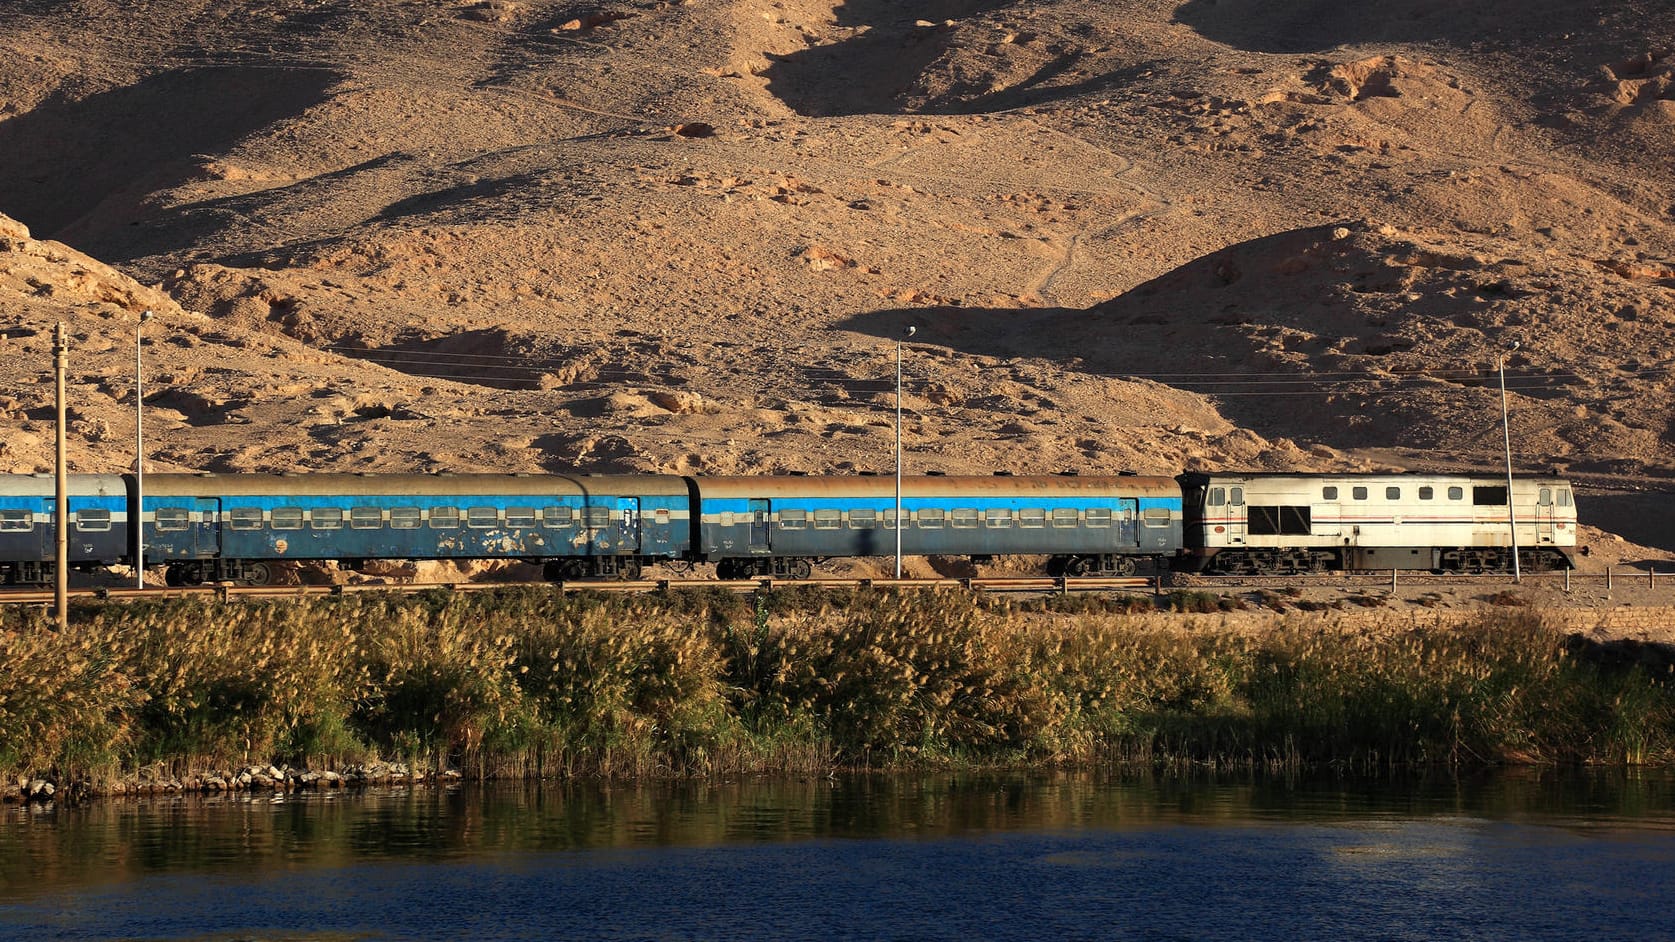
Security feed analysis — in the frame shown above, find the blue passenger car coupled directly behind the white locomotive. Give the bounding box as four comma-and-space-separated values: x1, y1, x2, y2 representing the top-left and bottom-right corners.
693, 476, 1181, 578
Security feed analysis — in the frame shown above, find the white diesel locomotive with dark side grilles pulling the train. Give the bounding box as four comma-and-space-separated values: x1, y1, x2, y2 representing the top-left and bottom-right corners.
1178, 473, 1576, 573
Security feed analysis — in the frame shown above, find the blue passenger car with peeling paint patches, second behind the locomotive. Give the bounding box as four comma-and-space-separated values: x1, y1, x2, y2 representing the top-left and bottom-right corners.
144, 474, 690, 585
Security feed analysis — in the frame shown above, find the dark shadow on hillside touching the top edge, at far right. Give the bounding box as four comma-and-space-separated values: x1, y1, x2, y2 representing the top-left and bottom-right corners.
1174, 0, 1603, 54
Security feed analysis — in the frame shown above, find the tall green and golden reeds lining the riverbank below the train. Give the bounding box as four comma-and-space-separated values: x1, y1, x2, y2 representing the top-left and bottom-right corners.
0, 590, 1675, 779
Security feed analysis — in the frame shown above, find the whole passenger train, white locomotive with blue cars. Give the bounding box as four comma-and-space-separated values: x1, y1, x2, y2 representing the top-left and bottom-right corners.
0, 473, 1576, 585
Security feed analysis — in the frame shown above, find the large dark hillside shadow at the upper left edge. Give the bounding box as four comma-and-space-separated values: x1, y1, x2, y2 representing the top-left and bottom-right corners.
0, 67, 338, 263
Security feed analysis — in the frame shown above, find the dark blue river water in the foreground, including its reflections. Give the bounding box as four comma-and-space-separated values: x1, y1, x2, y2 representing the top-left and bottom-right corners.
0, 771, 1675, 942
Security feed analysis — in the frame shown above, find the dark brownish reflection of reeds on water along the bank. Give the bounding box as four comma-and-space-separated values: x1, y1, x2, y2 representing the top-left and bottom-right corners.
0, 769, 1675, 898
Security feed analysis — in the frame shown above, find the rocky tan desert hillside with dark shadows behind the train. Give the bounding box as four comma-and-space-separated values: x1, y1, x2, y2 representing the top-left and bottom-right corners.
0, 0, 1675, 550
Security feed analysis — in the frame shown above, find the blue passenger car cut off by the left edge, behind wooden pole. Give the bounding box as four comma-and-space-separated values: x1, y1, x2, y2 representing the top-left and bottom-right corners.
0, 474, 129, 585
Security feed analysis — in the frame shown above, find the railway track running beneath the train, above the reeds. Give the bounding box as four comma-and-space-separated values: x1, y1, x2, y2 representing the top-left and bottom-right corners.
0, 570, 1675, 605
